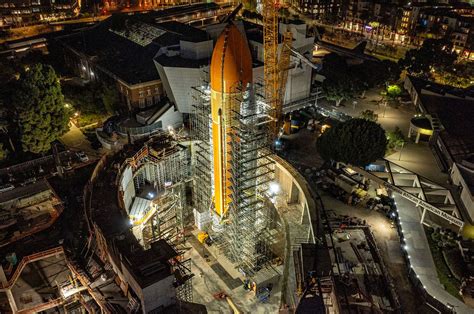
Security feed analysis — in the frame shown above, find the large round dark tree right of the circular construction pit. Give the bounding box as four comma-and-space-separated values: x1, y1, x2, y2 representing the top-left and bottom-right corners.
317, 119, 387, 166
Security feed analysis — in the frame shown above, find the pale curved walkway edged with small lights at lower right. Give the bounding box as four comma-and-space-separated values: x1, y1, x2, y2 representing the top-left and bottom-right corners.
395, 194, 473, 314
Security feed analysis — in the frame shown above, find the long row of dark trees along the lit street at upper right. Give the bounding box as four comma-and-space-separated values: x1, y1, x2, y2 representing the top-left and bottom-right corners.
322, 39, 468, 106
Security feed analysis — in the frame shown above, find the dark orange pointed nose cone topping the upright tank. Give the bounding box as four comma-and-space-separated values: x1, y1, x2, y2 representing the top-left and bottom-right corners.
211, 23, 252, 93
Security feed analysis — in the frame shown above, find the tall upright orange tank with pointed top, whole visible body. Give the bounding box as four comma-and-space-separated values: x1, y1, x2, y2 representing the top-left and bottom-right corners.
210, 22, 252, 218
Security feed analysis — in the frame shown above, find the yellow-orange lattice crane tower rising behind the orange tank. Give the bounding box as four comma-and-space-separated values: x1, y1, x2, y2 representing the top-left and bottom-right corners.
262, 0, 293, 138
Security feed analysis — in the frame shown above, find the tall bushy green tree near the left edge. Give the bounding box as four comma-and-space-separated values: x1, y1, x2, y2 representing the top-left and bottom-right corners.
14, 63, 69, 154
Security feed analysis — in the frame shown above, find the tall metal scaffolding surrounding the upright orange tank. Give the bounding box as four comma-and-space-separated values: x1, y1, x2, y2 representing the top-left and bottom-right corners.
192, 75, 274, 277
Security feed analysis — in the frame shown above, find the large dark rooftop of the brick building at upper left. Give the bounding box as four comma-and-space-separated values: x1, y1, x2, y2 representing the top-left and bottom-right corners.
59, 3, 218, 85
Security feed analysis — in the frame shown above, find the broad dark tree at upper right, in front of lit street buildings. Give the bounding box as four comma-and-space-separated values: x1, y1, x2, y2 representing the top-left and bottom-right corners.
399, 38, 458, 76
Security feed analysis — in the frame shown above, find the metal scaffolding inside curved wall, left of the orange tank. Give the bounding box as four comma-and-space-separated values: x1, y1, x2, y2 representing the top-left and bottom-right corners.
121, 134, 193, 302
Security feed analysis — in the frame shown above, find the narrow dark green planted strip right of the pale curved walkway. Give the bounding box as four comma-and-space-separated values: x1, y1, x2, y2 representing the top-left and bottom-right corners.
425, 228, 462, 301
